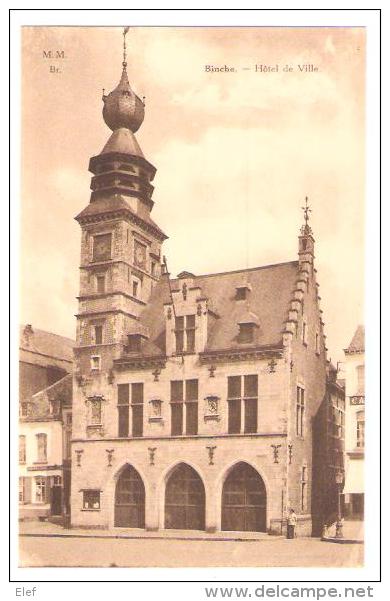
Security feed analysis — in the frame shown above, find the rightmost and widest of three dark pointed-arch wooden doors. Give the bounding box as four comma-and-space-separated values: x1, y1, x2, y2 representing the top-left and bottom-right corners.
221, 461, 267, 532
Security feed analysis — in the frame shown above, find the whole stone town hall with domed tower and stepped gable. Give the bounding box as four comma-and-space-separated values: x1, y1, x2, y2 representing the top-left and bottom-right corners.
71, 31, 336, 534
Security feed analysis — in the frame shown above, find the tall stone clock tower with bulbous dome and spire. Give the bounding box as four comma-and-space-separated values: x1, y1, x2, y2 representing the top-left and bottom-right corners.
76, 28, 167, 374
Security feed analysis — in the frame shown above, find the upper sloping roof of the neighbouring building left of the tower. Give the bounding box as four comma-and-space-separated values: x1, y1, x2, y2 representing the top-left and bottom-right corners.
19, 324, 76, 371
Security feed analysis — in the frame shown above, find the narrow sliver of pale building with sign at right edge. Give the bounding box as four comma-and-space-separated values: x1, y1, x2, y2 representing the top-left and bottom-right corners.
344, 325, 365, 519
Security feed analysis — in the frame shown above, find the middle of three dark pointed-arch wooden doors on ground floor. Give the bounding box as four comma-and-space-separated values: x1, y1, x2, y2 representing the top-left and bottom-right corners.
164, 463, 206, 530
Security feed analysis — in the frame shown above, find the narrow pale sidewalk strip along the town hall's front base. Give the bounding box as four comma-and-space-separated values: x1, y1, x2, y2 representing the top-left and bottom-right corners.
19, 521, 285, 541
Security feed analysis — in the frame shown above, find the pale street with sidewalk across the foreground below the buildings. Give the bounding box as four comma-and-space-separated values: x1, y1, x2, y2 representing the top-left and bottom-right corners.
20, 523, 364, 568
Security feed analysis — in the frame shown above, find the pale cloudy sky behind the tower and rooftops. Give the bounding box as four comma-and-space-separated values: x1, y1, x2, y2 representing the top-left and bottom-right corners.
21, 27, 365, 361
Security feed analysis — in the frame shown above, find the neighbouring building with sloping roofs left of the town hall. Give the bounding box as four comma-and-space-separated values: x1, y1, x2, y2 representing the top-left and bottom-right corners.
19, 325, 74, 519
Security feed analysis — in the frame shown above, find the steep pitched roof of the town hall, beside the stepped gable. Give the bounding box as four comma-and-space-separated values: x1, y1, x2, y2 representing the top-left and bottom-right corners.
125, 261, 298, 356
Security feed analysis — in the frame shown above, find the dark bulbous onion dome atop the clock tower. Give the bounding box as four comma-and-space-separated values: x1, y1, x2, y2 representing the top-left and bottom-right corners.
103, 68, 145, 133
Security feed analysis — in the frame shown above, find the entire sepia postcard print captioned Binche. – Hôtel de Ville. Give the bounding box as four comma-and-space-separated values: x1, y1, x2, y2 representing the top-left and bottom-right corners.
8, 11, 378, 596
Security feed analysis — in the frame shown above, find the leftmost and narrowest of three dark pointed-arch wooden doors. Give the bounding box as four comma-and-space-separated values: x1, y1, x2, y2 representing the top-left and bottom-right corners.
114, 464, 145, 528
